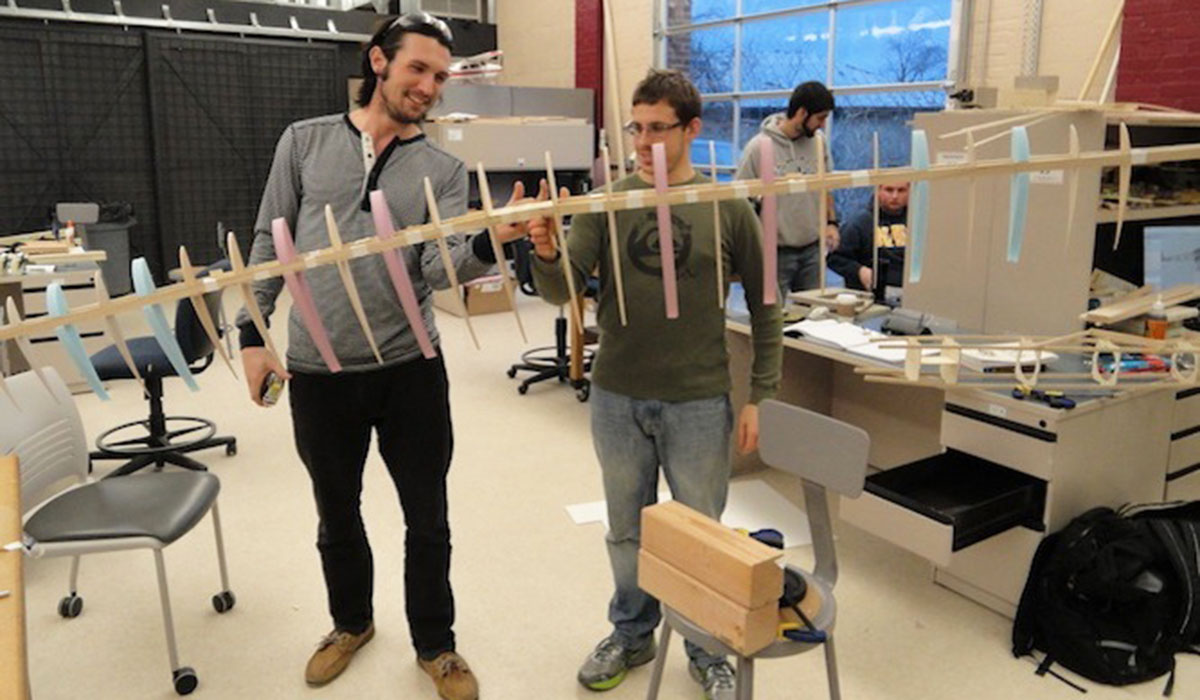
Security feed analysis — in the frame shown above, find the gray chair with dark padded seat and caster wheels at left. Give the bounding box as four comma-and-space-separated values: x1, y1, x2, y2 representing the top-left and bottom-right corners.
0, 367, 234, 695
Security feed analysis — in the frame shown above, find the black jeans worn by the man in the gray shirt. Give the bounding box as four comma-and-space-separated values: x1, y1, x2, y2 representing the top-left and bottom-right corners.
289, 355, 455, 659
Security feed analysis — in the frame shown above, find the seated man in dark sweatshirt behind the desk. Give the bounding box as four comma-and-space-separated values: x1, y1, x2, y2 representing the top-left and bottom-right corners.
828, 183, 908, 291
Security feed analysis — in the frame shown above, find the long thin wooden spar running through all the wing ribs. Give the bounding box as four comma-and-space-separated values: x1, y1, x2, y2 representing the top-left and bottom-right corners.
7, 138, 1200, 340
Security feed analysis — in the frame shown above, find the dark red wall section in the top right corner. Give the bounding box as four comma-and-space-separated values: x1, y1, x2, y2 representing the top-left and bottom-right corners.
1117, 0, 1200, 112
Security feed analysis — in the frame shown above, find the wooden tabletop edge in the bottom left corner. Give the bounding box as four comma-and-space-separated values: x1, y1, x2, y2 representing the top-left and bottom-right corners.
0, 455, 29, 698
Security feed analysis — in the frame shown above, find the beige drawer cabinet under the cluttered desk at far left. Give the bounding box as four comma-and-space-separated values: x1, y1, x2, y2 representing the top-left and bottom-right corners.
14, 264, 112, 394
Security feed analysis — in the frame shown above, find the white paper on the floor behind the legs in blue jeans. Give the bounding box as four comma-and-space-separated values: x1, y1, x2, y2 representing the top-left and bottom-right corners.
566, 479, 812, 548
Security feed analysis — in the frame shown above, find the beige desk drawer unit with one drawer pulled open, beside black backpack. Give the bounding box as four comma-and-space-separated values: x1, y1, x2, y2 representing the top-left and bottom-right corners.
840, 389, 1176, 617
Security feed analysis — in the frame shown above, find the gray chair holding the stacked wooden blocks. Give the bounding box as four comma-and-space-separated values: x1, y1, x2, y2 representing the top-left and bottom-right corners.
646, 401, 870, 700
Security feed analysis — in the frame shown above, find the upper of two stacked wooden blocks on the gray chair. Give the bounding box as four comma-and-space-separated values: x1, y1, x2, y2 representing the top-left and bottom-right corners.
642, 501, 784, 608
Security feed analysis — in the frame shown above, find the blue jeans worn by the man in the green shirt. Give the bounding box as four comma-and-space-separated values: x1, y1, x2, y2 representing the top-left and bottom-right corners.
590, 387, 733, 669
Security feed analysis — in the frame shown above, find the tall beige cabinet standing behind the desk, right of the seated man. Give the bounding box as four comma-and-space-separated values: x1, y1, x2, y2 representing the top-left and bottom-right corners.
902, 109, 1105, 335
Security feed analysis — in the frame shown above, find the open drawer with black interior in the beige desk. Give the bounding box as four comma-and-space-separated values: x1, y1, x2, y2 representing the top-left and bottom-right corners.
840, 449, 1046, 567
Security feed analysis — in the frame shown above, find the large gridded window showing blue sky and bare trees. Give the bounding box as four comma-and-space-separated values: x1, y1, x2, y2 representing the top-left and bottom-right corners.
655, 0, 965, 211
